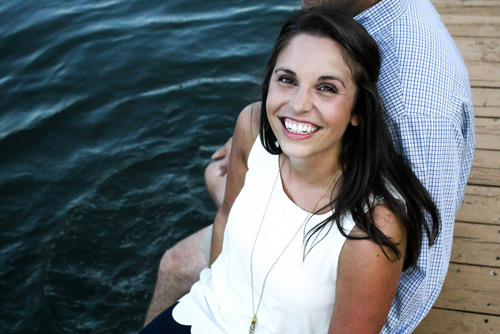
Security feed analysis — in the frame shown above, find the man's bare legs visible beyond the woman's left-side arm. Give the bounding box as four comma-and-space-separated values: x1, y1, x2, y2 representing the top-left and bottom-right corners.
145, 160, 227, 325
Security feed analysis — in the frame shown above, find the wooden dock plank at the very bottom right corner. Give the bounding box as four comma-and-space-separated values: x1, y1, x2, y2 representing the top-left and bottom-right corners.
413, 308, 500, 334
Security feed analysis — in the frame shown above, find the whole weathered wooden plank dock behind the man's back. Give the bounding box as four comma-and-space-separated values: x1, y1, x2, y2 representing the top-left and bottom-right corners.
414, 0, 500, 334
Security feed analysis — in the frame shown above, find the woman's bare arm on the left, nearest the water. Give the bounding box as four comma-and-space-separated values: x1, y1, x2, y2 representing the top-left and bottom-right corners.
210, 103, 260, 265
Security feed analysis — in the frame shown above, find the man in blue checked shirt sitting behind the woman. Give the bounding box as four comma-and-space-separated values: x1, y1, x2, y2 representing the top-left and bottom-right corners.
147, 0, 474, 333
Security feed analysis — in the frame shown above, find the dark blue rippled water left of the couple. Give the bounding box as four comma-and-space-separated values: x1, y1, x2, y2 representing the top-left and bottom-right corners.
0, 0, 299, 333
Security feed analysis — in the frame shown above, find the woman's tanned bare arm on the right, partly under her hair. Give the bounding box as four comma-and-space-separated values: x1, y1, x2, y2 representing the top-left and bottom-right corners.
328, 205, 406, 334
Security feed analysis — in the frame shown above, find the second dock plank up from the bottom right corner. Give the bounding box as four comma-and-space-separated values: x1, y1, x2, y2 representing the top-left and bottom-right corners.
434, 263, 500, 315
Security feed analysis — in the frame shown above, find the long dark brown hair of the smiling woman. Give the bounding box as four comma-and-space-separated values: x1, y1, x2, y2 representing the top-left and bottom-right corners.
259, 7, 440, 270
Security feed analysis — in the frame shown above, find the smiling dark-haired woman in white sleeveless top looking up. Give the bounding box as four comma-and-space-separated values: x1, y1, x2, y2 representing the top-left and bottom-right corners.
143, 8, 439, 333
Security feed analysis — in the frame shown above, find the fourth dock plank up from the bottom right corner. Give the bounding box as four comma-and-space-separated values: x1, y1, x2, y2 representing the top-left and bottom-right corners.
456, 185, 500, 226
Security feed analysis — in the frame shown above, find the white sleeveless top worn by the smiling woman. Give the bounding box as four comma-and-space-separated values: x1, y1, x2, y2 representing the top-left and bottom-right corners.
173, 138, 354, 334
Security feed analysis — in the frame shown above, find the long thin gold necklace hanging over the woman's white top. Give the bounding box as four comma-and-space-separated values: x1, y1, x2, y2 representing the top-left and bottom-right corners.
248, 157, 340, 334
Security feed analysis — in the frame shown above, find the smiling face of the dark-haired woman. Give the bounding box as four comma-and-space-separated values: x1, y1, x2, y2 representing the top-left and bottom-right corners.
266, 34, 358, 164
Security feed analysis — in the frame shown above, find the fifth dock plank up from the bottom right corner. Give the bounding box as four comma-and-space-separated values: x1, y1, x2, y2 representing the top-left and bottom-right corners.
468, 150, 500, 186
